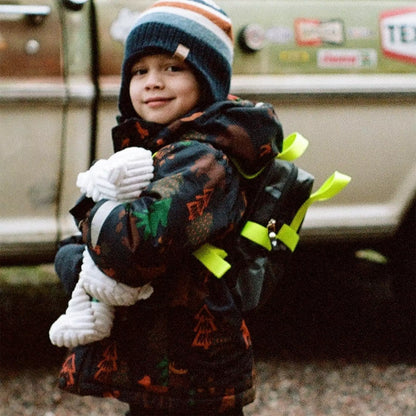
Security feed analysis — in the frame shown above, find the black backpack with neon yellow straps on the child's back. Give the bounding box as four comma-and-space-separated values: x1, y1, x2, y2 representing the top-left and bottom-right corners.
193, 133, 351, 313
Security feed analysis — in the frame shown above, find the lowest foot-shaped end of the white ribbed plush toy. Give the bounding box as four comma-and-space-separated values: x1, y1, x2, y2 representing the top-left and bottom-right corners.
49, 281, 114, 348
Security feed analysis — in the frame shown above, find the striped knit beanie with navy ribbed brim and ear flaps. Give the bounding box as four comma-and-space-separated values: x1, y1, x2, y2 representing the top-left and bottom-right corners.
119, 0, 233, 118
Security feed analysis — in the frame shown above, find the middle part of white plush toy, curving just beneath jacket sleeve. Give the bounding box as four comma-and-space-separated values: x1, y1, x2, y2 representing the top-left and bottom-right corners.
79, 249, 153, 306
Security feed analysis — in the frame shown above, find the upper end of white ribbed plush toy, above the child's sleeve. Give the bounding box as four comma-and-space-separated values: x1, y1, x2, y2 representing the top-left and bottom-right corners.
77, 147, 153, 201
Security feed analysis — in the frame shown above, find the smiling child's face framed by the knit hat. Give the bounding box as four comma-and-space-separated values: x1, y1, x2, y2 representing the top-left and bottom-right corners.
130, 54, 200, 124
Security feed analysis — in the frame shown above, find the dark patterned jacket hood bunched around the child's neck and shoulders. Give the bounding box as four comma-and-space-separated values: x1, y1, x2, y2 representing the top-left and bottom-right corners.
112, 99, 283, 174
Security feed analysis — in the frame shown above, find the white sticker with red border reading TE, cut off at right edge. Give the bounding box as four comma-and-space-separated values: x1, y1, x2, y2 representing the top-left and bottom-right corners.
380, 7, 416, 64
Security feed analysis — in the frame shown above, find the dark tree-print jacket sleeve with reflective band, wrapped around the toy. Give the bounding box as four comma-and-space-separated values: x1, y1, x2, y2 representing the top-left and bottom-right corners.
87, 141, 245, 286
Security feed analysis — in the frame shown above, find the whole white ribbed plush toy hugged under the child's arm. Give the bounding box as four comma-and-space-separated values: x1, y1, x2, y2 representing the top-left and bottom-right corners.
49, 147, 153, 348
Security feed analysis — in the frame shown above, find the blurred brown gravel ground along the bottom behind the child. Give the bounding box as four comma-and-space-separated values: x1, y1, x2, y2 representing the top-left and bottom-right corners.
0, 358, 416, 416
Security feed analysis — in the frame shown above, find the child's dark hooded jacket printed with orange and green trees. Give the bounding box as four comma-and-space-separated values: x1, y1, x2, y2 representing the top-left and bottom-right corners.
60, 99, 282, 415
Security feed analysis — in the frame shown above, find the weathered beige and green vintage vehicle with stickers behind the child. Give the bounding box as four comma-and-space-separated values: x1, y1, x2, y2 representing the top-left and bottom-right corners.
0, 0, 416, 260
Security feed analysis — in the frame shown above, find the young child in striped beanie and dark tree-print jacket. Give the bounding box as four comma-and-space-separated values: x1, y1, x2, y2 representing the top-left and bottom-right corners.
55, 0, 283, 416
